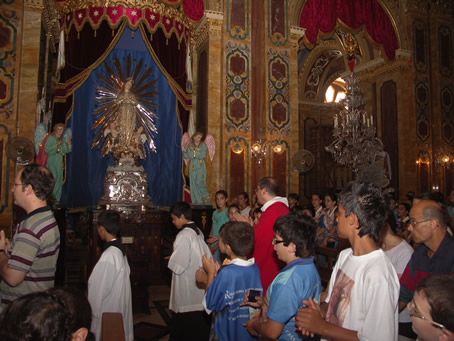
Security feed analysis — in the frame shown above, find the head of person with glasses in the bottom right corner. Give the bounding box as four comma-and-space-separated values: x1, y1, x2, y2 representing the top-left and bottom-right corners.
407, 274, 454, 341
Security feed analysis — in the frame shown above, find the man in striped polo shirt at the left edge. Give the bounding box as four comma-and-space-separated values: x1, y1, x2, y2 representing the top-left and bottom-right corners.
0, 165, 60, 310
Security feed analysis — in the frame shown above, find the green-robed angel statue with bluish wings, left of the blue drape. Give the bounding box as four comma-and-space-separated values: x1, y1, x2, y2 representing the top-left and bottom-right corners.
34, 123, 72, 202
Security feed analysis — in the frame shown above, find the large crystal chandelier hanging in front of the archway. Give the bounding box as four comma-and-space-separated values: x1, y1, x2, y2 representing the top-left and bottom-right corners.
325, 72, 383, 175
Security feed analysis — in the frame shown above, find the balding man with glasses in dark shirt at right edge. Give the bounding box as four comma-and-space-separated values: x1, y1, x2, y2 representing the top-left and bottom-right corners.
399, 200, 454, 334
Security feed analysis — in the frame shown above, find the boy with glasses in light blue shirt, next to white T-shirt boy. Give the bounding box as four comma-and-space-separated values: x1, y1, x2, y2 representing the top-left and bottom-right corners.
245, 213, 321, 340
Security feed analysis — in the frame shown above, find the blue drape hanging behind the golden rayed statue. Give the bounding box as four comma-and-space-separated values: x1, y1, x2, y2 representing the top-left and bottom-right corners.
61, 29, 183, 208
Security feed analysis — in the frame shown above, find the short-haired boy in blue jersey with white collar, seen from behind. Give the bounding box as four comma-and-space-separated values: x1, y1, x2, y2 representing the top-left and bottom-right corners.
197, 221, 262, 341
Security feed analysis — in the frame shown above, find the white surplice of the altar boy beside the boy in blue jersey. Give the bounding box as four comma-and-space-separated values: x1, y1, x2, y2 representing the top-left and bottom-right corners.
168, 227, 212, 313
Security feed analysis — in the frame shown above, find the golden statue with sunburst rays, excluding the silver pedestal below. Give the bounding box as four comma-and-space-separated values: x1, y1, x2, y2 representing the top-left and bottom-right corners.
92, 56, 158, 163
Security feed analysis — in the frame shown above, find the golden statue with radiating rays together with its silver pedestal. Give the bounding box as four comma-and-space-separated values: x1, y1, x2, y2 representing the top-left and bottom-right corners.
92, 56, 158, 210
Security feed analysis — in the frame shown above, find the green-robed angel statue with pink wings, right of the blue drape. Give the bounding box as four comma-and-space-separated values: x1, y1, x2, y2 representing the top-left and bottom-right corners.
181, 132, 215, 205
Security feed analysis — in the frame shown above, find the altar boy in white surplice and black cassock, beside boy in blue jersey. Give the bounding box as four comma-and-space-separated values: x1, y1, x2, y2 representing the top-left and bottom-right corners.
168, 201, 211, 341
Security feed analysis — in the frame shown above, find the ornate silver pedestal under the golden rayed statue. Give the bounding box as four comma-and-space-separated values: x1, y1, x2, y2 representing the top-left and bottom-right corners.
98, 159, 153, 214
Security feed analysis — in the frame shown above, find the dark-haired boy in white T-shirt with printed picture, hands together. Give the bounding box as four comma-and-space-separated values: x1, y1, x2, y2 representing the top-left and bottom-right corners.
296, 183, 399, 341
